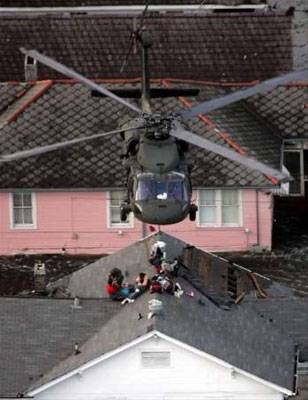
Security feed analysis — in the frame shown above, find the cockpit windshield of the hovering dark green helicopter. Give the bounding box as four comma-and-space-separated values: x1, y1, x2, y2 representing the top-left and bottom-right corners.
136, 172, 188, 201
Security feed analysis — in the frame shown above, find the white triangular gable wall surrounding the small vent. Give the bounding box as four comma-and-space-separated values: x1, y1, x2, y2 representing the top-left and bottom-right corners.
34, 338, 283, 400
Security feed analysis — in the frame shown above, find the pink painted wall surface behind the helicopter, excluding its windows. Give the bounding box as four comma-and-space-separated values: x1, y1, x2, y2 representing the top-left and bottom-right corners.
0, 190, 272, 254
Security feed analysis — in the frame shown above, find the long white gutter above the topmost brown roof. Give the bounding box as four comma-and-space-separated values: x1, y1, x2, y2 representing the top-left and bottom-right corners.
0, 4, 268, 15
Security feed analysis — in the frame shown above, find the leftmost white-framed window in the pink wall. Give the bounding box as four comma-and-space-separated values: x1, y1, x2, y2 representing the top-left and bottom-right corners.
11, 192, 36, 229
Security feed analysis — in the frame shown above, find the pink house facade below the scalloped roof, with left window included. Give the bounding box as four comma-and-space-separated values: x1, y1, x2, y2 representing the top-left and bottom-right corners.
0, 189, 272, 254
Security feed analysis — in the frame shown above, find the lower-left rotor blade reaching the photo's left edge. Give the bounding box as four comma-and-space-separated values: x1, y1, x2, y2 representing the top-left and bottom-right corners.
0, 127, 141, 163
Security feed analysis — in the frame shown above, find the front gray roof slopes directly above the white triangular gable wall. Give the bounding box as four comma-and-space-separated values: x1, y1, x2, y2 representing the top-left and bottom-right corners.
26, 279, 295, 390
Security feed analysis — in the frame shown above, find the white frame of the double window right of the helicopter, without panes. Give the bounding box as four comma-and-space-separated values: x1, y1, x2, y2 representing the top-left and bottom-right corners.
197, 188, 243, 228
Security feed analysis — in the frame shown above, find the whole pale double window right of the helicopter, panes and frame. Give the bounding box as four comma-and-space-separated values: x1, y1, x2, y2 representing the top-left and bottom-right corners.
198, 189, 242, 226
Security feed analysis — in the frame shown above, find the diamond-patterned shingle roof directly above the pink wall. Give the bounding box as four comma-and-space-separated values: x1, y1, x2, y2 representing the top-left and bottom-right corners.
0, 83, 280, 189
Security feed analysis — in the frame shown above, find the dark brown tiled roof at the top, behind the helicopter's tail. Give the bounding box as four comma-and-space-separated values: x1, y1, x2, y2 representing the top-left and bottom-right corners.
0, 12, 292, 81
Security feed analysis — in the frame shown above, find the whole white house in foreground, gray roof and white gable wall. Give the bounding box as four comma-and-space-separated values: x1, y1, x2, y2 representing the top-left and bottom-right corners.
0, 232, 308, 400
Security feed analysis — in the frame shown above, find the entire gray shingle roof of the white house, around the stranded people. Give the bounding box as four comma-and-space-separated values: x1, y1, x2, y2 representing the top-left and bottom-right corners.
0, 232, 308, 396
